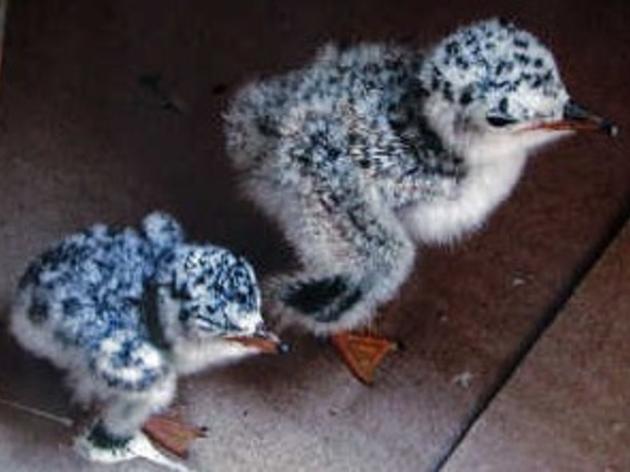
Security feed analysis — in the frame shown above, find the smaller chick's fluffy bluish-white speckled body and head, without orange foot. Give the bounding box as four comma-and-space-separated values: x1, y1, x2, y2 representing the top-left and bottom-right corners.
11, 213, 277, 461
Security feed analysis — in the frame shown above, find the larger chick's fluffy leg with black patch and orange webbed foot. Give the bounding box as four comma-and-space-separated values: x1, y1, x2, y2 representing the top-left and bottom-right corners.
267, 182, 414, 383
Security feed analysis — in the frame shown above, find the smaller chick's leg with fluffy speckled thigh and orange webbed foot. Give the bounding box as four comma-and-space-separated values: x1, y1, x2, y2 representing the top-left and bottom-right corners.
79, 336, 198, 461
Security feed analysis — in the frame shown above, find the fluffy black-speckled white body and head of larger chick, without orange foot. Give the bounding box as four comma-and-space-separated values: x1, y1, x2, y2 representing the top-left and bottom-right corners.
226, 19, 614, 334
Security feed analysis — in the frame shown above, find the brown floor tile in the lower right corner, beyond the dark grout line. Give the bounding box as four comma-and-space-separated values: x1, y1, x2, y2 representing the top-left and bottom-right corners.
443, 225, 630, 472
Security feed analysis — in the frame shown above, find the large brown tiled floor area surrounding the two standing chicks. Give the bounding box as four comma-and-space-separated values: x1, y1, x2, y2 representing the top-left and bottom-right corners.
0, 0, 630, 472
